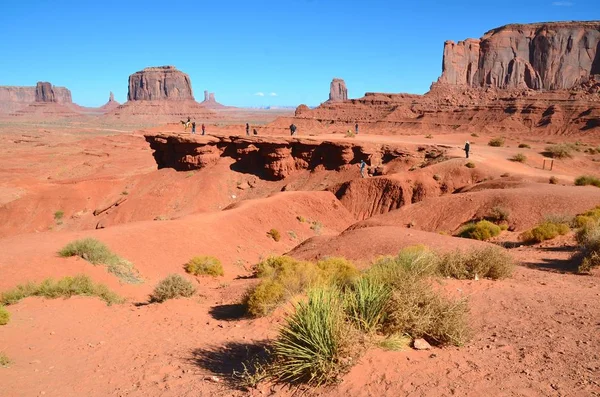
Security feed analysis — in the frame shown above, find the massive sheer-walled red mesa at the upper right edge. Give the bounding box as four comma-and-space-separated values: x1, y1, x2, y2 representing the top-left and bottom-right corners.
438, 21, 600, 90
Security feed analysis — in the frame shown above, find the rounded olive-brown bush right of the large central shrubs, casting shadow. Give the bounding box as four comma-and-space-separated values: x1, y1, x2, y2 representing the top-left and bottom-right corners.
438, 247, 514, 280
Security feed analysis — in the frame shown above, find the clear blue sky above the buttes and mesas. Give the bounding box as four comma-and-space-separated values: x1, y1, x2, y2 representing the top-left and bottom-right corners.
0, 0, 600, 106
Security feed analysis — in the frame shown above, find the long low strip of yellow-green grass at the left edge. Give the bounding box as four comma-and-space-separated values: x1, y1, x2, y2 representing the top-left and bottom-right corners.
0, 274, 123, 305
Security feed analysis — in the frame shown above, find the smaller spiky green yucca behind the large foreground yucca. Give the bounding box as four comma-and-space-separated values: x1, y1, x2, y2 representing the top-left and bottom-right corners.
344, 277, 392, 333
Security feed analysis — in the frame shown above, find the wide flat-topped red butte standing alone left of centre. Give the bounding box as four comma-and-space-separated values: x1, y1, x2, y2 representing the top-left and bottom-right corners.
127, 66, 194, 101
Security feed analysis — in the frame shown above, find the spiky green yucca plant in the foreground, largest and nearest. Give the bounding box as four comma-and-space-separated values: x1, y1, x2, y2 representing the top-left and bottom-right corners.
272, 288, 352, 385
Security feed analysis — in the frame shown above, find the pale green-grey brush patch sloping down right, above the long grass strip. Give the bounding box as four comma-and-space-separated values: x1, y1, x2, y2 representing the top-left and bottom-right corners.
58, 238, 143, 284
